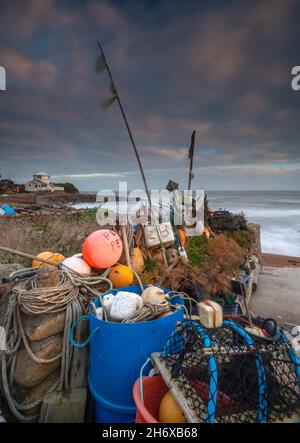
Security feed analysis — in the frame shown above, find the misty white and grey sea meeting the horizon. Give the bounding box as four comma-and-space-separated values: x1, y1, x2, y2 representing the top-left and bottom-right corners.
74, 191, 300, 257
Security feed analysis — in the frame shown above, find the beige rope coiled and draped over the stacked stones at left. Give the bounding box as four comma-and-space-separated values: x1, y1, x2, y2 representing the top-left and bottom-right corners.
1, 268, 112, 422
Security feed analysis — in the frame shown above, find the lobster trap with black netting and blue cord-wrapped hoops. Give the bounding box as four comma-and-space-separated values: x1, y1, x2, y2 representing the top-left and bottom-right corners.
152, 320, 300, 423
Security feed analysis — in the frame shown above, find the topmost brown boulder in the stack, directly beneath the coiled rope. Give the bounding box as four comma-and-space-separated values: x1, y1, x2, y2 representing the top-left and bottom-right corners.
23, 312, 66, 341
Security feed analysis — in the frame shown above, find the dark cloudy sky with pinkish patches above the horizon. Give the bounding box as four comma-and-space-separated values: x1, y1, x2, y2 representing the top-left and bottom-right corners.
0, 0, 300, 191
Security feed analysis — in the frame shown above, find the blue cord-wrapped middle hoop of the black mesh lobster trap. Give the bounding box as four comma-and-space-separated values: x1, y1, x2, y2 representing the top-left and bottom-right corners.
223, 320, 267, 423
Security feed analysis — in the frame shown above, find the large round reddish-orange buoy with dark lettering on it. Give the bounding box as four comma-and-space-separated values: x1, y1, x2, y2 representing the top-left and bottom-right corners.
82, 229, 123, 269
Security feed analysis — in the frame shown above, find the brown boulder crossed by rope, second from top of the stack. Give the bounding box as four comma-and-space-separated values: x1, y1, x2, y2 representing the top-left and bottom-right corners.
14, 335, 62, 388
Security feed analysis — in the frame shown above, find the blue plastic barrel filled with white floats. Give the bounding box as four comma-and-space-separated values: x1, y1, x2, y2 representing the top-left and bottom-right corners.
71, 286, 184, 423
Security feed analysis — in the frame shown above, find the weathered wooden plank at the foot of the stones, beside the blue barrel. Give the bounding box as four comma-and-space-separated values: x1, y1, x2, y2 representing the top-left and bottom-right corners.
39, 388, 87, 423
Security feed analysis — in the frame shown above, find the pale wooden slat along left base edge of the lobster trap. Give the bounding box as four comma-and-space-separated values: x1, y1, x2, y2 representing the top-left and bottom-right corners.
151, 352, 199, 423
